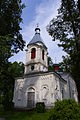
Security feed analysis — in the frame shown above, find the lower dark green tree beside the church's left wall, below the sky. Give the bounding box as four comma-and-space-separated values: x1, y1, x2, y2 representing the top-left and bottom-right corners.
0, 62, 24, 109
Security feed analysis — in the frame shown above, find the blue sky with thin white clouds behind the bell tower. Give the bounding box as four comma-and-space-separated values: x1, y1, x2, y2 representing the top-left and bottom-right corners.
10, 0, 66, 63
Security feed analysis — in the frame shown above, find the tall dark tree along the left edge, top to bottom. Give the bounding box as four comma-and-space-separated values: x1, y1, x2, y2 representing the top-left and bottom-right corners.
0, 0, 25, 107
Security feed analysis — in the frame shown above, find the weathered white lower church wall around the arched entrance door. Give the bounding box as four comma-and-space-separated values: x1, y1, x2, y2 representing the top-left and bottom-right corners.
14, 73, 65, 108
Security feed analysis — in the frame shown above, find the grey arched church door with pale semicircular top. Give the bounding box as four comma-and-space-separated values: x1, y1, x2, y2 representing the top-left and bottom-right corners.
27, 88, 35, 108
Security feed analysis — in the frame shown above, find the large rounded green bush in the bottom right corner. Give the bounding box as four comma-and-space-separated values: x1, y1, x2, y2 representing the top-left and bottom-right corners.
48, 99, 80, 120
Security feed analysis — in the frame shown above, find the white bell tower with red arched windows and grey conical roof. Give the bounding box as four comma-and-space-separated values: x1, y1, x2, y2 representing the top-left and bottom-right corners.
25, 26, 48, 74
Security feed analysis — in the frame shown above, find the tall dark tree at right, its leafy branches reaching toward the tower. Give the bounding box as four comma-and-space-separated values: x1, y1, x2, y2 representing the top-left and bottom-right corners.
47, 0, 80, 101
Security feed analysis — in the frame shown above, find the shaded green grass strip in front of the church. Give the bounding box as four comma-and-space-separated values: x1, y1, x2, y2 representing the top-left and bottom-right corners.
0, 111, 50, 120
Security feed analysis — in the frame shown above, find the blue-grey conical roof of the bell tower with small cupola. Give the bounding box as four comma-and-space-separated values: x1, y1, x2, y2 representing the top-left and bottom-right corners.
28, 27, 47, 48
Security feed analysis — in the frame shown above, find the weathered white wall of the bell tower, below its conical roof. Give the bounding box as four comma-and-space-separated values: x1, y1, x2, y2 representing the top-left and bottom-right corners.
24, 43, 48, 74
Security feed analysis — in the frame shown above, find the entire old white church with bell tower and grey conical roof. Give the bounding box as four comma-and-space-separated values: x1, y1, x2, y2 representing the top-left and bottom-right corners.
13, 26, 78, 109
